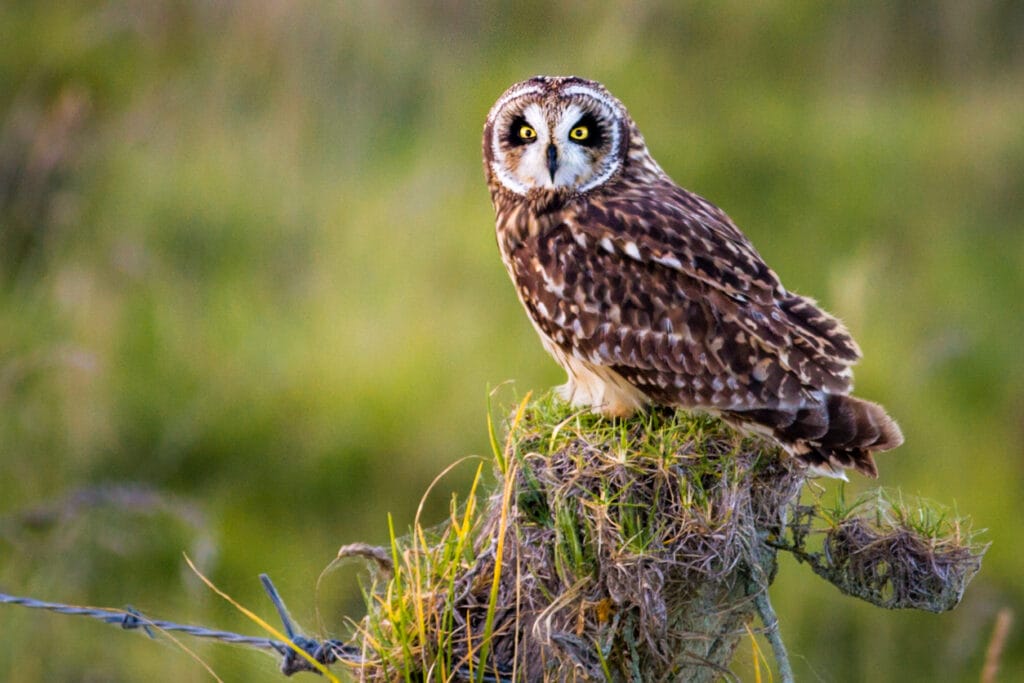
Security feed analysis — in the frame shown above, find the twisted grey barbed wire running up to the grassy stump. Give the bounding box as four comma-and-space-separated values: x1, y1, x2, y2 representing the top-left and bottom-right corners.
0, 573, 511, 683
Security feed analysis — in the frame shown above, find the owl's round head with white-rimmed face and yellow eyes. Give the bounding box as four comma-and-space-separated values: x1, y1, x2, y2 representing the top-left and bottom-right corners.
483, 76, 633, 196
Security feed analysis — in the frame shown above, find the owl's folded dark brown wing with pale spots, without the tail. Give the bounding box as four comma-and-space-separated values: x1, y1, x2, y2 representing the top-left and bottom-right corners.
506, 183, 859, 411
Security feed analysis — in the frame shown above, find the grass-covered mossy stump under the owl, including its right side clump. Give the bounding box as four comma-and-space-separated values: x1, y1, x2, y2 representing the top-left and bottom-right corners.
348, 398, 984, 681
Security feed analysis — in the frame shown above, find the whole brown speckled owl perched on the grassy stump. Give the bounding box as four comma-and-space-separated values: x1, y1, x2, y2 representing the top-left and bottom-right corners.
483, 76, 903, 478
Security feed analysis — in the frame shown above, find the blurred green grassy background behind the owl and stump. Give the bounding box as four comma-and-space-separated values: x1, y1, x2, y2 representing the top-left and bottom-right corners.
0, 0, 1024, 682
